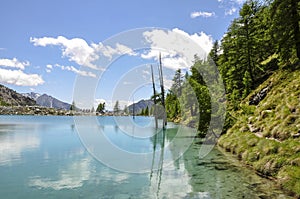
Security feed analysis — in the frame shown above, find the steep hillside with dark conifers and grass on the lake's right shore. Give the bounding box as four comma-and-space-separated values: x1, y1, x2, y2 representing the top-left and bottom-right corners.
166, 0, 300, 196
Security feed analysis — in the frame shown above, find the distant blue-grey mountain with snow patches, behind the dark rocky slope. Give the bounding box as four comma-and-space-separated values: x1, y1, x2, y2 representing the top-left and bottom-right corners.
23, 92, 71, 110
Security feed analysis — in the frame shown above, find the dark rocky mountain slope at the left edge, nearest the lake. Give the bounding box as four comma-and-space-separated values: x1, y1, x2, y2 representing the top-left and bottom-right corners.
0, 84, 36, 106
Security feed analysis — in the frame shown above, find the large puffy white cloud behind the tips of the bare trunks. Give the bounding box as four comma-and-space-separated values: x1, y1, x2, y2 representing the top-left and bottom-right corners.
141, 28, 213, 70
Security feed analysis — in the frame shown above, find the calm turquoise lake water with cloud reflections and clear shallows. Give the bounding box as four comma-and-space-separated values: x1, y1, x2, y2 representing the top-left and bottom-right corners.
0, 116, 288, 199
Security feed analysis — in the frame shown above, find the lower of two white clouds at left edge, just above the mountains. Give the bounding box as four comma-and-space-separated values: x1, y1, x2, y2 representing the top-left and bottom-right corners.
0, 68, 44, 86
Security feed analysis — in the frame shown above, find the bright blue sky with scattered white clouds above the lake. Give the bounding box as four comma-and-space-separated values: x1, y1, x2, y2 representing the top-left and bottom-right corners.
0, 0, 244, 107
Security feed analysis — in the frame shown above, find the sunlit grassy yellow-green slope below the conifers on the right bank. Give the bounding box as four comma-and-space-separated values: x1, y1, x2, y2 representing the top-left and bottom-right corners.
218, 70, 300, 196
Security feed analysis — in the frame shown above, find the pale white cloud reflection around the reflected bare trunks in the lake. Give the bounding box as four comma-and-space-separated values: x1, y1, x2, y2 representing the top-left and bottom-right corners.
149, 128, 210, 199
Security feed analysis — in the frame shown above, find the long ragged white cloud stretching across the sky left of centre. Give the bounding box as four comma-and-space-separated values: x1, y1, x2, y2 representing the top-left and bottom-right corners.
30, 36, 135, 70
